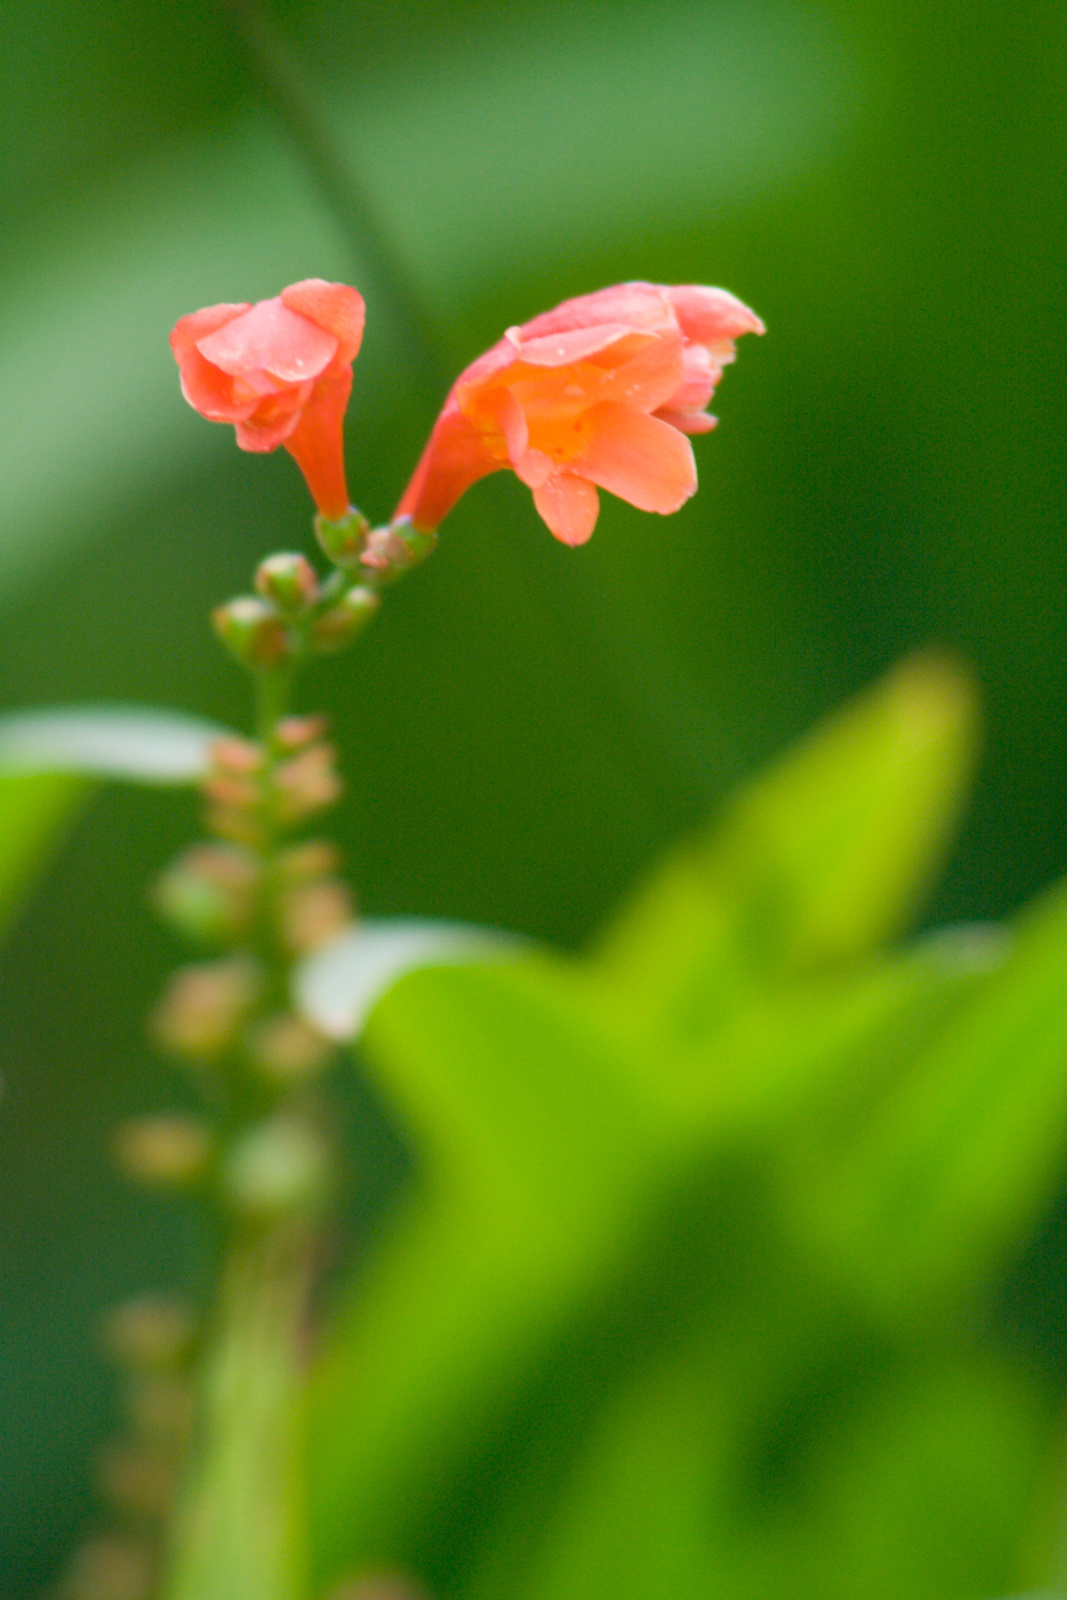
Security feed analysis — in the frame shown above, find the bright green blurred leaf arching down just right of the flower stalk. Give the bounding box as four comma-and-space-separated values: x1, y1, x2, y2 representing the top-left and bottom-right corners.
302, 958, 659, 1573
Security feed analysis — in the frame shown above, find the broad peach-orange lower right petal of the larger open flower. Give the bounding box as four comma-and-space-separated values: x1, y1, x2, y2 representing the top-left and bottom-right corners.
571, 402, 696, 514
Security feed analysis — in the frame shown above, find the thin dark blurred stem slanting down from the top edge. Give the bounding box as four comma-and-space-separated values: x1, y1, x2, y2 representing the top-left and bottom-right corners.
221, 0, 451, 398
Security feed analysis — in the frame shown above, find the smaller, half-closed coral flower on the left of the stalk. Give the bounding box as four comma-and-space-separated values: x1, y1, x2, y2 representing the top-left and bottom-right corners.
171, 278, 363, 520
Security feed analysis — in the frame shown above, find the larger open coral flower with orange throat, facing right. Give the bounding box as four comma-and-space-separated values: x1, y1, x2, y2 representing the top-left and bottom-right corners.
397, 283, 763, 544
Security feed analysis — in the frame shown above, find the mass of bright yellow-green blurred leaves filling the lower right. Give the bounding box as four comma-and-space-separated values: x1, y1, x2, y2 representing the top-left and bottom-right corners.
302, 659, 1067, 1600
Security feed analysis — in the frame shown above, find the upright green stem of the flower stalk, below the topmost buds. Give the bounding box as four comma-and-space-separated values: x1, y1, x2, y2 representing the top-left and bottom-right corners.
162, 662, 318, 1600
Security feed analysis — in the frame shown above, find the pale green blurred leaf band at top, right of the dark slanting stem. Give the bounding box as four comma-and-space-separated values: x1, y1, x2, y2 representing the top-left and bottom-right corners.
341, 0, 865, 294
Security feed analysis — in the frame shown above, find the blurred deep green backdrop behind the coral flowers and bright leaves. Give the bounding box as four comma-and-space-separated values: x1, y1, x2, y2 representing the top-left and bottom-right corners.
0, 0, 1067, 1600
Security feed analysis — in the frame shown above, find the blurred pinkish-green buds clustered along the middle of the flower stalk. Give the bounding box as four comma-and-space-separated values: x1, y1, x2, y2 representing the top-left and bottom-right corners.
139, 710, 343, 1219
